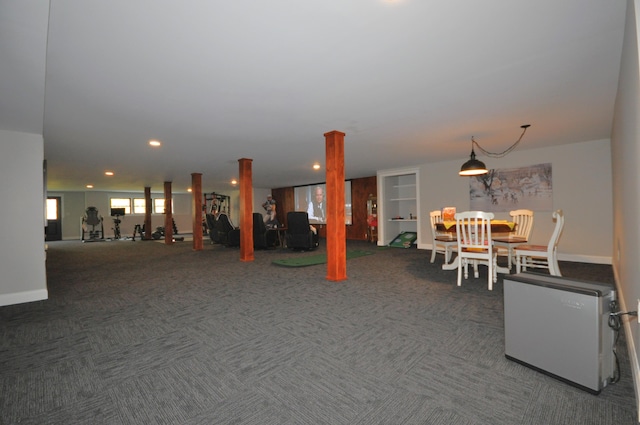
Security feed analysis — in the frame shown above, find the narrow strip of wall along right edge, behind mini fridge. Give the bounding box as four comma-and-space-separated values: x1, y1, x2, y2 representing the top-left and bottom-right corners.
611, 0, 640, 415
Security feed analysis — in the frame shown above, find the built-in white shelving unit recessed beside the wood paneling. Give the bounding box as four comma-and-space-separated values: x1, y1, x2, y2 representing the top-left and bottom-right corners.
378, 168, 420, 245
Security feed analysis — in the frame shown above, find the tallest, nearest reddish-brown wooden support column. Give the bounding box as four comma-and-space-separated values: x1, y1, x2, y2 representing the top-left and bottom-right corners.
324, 130, 347, 281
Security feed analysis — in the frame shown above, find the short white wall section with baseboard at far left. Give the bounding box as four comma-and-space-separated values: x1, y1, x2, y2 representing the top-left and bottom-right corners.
0, 130, 48, 305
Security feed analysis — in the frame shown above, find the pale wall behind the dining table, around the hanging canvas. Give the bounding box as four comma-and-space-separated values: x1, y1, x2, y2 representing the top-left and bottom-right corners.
418, 138, 613, 264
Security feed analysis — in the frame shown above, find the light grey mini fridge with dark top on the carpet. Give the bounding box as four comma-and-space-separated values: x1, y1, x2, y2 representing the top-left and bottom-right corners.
504, 273, 616, 394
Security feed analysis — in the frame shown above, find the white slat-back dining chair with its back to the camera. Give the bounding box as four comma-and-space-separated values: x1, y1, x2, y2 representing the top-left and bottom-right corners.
456, 211, 498, 291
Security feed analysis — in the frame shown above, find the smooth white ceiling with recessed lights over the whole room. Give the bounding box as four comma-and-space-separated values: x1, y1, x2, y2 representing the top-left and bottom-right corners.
0, 0, 627, 192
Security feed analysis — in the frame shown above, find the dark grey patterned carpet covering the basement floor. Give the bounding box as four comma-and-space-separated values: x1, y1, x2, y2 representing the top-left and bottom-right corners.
0, 241, 636, 425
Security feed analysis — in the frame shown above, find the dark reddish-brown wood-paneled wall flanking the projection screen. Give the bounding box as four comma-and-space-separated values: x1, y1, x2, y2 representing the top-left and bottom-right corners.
271, 176, 378, 240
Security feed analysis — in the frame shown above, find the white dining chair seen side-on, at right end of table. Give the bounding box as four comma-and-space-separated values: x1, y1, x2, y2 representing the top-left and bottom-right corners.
514, 210, 564, 276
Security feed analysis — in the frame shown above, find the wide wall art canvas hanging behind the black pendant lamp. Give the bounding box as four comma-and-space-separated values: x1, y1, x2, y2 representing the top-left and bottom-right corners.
469, 163, 553, 212
